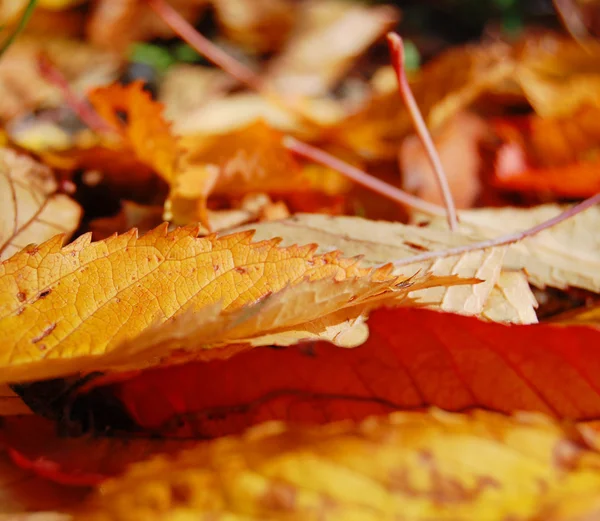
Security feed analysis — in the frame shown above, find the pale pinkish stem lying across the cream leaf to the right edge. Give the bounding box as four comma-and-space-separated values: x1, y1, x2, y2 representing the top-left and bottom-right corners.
392, 193, 600, 266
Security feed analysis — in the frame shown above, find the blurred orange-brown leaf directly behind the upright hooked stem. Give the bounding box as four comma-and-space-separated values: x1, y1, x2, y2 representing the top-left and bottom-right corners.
398, 112, 487, 208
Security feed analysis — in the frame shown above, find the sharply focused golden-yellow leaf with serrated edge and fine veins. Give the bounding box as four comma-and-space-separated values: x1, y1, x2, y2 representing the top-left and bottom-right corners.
0, 227, 418, 382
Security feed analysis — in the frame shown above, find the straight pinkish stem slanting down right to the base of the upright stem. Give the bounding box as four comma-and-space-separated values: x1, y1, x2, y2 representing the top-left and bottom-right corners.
283, 136, 446, 217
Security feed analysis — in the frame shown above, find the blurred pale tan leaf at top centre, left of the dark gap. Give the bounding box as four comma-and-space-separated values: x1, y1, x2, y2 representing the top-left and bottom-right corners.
267, 0, 397, 96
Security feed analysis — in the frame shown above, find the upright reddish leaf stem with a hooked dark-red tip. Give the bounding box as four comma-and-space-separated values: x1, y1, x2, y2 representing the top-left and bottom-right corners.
387, 33, 458, 231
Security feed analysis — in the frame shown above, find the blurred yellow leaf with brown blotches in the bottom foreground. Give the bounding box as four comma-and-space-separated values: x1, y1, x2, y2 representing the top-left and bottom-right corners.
76, 411, 600, 521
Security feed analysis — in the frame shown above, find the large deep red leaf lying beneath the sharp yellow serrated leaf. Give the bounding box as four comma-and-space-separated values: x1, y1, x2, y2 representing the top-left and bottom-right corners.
85, 308, 600, 437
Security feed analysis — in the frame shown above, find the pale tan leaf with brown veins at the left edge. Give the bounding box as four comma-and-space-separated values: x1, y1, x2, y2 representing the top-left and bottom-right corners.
0, 148, 81, 259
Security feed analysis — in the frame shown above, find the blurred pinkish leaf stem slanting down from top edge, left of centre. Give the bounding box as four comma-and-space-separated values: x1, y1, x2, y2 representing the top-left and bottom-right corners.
147, 0, 264, 92
